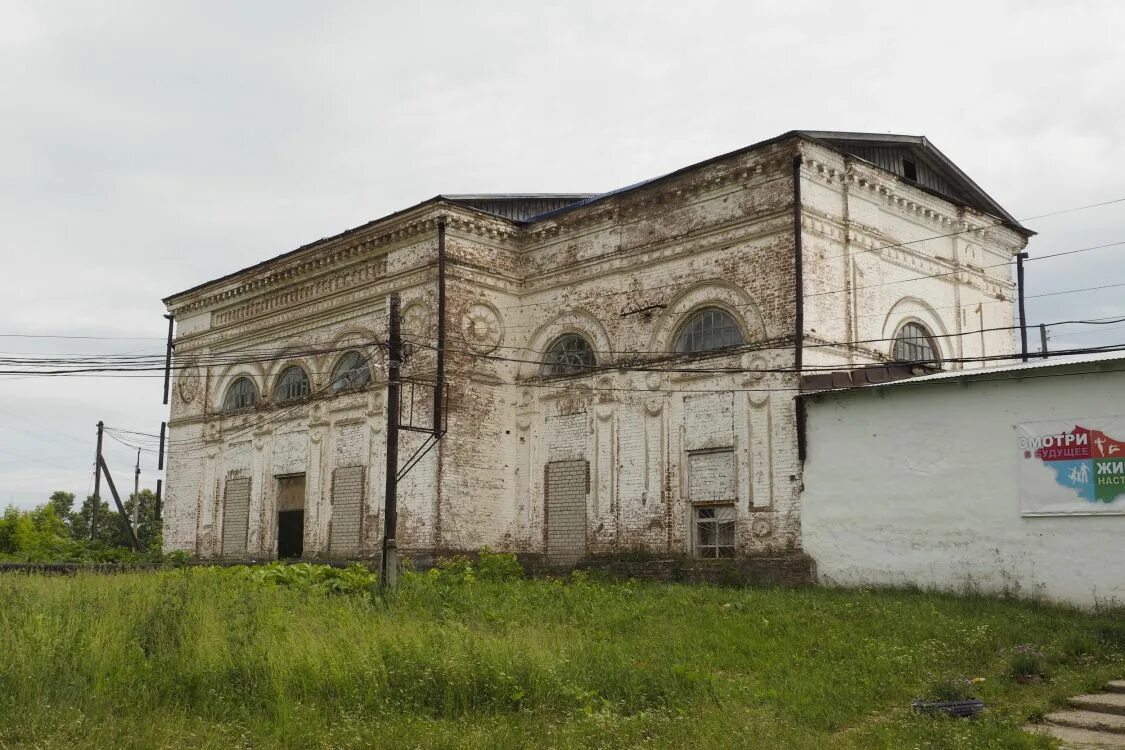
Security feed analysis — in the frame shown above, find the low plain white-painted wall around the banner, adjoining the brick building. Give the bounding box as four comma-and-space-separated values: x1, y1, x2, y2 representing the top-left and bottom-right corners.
801, 365, 1125, 606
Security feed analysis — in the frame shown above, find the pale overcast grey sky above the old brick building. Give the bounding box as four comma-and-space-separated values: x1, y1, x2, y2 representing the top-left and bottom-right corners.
0, 0, 1125, 506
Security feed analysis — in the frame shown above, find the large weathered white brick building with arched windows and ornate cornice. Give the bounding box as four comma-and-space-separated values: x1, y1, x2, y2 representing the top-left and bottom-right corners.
164, 132, 1031, 564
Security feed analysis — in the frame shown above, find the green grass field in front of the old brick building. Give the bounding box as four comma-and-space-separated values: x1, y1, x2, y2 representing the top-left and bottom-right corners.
0, 568, 1125, 750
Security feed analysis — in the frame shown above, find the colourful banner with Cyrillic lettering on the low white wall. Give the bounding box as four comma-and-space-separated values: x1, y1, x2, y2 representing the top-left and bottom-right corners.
1016, 416, 1125, 516
